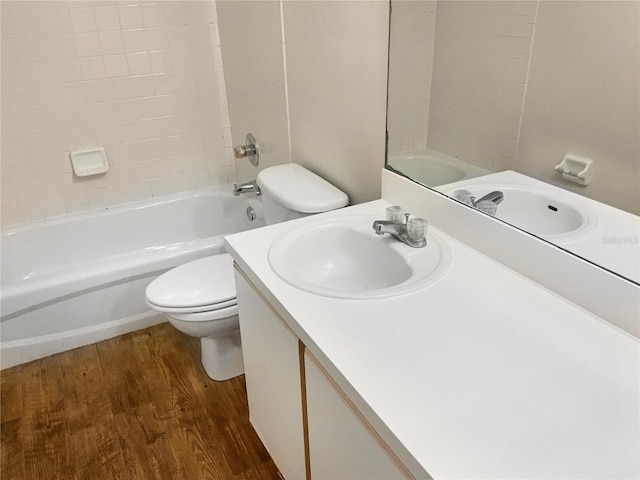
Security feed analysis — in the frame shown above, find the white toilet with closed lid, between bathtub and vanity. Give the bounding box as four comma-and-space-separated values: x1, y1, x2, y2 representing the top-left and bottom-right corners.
145, 163, 349, 381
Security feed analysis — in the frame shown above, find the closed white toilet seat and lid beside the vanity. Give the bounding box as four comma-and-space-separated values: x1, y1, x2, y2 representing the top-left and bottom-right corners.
145, 253, 238, 321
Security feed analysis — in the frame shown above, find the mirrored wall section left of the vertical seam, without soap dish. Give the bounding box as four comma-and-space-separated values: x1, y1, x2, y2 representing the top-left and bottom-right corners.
427, 0, 537, 171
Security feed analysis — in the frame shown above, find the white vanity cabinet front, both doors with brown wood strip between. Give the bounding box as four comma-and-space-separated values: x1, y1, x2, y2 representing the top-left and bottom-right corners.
235, 267, 412, 480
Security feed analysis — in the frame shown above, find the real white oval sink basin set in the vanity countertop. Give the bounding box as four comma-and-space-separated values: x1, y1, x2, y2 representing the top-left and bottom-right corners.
269, 214, 451, 299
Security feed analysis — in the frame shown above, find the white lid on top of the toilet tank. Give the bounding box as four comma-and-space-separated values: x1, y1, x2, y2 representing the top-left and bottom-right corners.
257, 163, 349, 213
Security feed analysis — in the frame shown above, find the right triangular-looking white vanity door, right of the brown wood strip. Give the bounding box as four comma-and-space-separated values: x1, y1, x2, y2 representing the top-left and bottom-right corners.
304, 352, 411, 480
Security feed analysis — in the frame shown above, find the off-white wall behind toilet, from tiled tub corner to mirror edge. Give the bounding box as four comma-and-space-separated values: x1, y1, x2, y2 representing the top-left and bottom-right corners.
218, 0, 388, 203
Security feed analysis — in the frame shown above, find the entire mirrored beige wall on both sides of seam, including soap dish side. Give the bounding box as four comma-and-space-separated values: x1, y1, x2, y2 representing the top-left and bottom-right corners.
396, 0, 640, 213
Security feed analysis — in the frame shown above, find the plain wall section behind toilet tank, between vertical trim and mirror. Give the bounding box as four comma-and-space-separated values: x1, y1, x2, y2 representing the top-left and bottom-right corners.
284, 0, 389, 203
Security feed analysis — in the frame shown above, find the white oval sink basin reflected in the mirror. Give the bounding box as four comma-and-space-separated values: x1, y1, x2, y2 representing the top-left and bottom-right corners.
451, 184, 598, 240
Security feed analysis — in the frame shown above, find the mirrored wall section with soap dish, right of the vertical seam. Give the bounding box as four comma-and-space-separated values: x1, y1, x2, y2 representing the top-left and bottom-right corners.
516, 1, 640, 214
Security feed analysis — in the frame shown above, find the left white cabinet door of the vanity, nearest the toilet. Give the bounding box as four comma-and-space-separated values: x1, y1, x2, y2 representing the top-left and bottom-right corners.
235, 271, 305, 480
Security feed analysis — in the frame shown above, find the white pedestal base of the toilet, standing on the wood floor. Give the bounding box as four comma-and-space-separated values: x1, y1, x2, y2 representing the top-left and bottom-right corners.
200, 330, 244, 382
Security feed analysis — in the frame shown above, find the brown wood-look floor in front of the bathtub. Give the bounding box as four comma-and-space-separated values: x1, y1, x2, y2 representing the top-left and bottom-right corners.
0, 323, 279, 480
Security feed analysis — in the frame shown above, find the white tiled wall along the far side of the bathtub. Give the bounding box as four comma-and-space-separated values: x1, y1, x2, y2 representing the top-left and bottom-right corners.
0, 0, 235, 225
